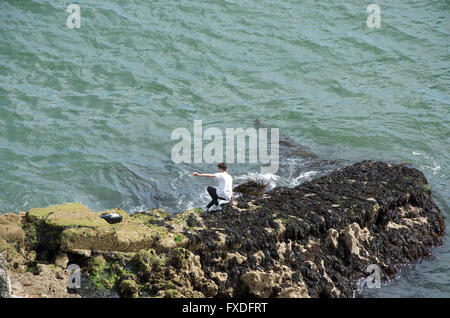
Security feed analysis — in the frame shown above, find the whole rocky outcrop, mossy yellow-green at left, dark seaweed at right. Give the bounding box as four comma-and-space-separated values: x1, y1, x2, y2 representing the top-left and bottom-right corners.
0, 161, 444, 297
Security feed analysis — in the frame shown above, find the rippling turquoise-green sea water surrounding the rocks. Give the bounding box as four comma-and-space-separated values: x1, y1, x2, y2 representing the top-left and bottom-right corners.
0, 0, 450, 297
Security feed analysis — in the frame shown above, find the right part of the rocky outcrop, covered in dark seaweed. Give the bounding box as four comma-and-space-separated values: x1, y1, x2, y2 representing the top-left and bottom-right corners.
196, 161, 444, 297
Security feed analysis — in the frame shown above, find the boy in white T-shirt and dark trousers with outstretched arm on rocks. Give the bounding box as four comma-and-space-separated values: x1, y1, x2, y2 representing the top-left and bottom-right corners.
192, 162, 236, 211
